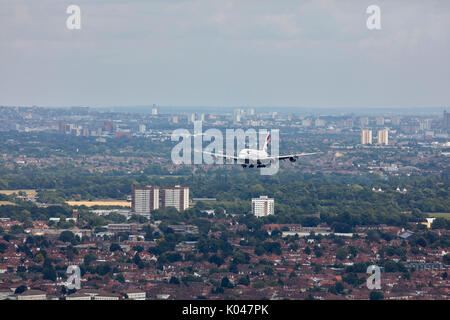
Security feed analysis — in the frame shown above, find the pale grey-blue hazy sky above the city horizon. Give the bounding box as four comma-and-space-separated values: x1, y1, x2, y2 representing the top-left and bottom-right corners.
0, 0, 450, 108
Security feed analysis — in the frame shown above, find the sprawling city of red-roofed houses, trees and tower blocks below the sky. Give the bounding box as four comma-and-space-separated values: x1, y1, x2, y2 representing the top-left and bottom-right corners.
0, 106, 450, 300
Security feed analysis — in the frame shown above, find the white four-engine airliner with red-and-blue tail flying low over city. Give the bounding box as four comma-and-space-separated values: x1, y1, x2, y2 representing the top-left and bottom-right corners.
203, 133, 318, 168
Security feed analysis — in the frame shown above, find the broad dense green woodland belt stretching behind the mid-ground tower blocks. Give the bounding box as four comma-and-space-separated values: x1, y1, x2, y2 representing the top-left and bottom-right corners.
0, 164, 450, 228
